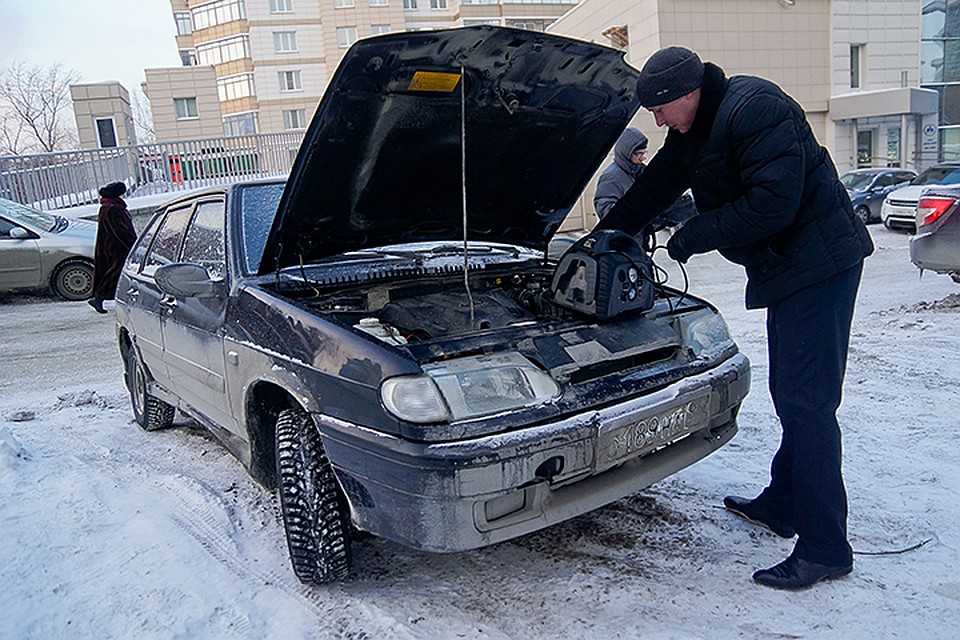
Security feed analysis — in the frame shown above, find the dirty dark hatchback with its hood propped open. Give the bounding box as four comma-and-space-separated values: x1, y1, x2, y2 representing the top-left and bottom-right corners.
117, 27, 750, 583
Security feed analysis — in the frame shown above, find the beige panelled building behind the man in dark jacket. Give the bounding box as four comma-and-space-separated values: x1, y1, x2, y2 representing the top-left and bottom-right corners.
547, 0, 937, 228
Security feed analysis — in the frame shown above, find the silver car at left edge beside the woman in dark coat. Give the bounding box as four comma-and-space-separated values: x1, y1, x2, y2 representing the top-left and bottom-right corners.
0, 198, 97, 300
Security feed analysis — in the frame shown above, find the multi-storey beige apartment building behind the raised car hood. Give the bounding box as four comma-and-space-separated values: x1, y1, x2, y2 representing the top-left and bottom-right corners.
145, 0, 578, 140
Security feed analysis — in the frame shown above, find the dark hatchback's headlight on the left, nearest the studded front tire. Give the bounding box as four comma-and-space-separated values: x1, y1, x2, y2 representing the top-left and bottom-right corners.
381, 353, 560, 423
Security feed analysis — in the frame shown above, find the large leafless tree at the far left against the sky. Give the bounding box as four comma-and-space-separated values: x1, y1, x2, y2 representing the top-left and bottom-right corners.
0, 62, 80, 152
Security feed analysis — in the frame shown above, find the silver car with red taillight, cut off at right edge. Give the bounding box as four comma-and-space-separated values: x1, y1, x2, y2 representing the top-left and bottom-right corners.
910, 187, 960, 283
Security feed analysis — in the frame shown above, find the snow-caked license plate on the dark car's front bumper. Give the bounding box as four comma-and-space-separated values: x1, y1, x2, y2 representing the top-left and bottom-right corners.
597, 390, 710, 468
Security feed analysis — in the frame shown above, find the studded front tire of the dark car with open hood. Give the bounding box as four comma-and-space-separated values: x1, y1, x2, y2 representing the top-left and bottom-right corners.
276, 409, 351, 584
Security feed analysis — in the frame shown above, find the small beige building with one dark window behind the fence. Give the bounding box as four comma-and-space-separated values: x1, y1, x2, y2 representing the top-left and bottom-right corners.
70, 82, 137, 149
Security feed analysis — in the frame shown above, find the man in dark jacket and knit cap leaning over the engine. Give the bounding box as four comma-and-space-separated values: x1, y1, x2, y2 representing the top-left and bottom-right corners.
598, 47, 873, 589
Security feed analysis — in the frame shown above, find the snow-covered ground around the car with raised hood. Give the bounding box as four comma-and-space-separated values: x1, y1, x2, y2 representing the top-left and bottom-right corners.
0, 228, 960, 640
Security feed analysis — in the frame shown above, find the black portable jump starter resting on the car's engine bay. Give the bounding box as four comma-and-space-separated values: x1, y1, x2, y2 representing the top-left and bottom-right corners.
550, 229, 654, 322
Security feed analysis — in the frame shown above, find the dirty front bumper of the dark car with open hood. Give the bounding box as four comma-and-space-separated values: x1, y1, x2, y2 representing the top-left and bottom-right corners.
314, 354, 750, 552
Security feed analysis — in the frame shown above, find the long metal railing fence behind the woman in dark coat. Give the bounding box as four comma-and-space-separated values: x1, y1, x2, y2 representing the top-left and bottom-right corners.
0, 132, 303, 209
